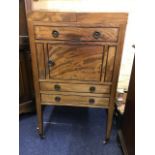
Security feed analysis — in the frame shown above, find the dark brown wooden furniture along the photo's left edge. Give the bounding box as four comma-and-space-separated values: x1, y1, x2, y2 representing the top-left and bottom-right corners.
19, 0, 35, 114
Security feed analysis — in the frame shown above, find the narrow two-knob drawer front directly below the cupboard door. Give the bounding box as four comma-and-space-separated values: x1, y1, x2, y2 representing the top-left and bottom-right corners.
40, 82, 111, 94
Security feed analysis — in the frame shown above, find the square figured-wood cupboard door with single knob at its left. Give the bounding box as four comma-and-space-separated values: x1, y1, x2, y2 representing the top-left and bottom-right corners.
48, 44, 103, 81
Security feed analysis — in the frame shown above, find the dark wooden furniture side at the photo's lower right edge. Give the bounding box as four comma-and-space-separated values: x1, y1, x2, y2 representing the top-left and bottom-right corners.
118, 57, 135, 155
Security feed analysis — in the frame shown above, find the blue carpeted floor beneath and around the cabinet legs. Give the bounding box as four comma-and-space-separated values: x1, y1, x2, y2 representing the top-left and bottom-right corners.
19, 107, 122, 155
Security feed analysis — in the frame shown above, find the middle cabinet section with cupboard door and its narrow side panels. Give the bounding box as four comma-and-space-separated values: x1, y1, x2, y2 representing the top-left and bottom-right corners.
36, 43, 117, 83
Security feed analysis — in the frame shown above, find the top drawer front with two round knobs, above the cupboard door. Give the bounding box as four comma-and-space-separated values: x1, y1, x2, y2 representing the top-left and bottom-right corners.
34, 26, 119, 42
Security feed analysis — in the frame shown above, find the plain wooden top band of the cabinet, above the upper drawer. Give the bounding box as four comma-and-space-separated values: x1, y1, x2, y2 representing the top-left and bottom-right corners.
28, 11, 128, 24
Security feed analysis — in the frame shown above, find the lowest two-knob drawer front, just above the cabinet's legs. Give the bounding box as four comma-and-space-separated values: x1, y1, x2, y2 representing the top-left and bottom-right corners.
41, 94, 109, 106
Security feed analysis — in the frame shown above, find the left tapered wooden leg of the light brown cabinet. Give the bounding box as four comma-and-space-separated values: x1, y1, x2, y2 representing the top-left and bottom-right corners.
37, 105, 44, 138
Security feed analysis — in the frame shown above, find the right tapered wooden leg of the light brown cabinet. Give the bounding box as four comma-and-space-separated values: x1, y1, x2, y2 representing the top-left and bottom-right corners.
104, 107, 114, 144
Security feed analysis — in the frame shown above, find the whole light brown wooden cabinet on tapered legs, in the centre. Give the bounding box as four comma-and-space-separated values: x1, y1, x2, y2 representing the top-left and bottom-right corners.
28, 11, 127, 141
